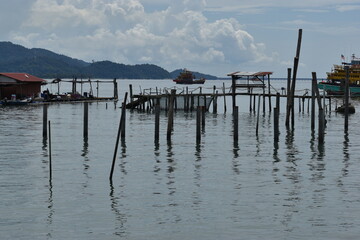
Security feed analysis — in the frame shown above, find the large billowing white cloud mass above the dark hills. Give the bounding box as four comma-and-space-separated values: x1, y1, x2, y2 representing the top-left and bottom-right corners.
9, 0, 271, 74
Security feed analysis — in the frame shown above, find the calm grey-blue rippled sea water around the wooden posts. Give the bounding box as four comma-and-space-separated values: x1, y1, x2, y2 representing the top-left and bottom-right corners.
0, 80, 360, 240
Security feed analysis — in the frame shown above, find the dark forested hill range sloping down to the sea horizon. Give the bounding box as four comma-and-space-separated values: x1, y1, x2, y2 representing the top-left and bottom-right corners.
0, 42, 217, 79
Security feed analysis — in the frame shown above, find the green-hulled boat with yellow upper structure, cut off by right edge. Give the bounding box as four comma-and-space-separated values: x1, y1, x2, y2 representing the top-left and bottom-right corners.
318, 54, 360, 96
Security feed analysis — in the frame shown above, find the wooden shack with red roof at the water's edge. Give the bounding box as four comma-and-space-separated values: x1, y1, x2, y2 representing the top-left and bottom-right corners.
0, 73, 46, 99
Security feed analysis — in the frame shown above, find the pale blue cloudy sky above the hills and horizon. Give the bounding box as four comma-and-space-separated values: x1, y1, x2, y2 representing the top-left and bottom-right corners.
0, 0, 360, 78
